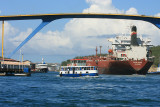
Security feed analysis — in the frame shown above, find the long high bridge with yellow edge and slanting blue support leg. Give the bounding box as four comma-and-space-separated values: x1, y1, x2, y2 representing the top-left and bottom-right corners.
0, 13, 160, 58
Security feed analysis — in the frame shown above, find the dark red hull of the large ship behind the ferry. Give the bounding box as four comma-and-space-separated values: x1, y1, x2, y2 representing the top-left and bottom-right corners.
87, 60, 153, 75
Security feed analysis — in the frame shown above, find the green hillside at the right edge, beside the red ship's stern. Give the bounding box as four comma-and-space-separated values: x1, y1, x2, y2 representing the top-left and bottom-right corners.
151, 46, 160, 66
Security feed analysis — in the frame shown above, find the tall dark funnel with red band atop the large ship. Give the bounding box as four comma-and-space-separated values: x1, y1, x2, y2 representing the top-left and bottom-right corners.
131, 25, 139, 46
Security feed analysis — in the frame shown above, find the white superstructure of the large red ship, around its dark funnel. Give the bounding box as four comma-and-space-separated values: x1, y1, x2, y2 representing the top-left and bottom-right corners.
108, 26, 152, 60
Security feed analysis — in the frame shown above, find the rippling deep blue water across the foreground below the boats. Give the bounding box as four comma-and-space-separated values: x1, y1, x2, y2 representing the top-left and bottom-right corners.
0, 72, 160, 107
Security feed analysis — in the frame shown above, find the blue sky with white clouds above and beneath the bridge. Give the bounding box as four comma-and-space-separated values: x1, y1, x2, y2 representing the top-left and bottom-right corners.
0, 0, 160, 63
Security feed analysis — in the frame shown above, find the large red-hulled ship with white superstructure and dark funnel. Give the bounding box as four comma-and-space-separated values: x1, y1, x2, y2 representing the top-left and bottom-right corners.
68, 26, 154, 75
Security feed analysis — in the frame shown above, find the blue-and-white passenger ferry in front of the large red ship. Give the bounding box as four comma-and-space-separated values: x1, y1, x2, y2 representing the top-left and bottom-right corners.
59, 66, 98, 77
